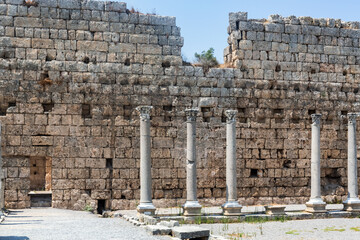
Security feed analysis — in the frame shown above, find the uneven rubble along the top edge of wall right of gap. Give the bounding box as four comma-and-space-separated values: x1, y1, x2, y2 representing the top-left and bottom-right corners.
229, 12, 360, 29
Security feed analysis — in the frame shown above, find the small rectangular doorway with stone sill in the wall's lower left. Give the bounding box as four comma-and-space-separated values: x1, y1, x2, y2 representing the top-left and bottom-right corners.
29, 157, 52, 207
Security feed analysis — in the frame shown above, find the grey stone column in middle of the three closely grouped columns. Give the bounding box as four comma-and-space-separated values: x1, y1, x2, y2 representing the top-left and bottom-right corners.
183, 108, 201, 216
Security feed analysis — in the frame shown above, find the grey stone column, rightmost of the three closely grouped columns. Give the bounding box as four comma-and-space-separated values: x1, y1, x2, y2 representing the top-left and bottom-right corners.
222, 110, 242, 215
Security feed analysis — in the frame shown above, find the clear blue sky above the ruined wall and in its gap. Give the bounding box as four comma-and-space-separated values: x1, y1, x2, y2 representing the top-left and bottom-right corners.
124, 0, 360, 62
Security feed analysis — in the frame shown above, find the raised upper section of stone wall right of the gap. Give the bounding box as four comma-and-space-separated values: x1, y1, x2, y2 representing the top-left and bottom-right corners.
224, 12, 360, 83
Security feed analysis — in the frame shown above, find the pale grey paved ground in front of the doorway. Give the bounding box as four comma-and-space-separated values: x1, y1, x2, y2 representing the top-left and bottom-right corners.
0, 208, 170, 240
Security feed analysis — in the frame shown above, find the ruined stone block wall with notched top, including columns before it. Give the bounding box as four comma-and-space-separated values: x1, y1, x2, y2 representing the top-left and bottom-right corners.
0, 0, 360, 214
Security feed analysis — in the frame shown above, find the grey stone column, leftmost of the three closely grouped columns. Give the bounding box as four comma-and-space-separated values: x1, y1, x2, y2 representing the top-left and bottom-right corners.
136, 106, 156, 215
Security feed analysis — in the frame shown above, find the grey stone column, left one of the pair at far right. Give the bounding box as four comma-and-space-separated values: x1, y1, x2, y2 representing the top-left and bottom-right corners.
305, 114, 326, 213
